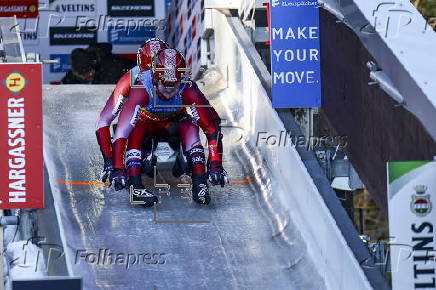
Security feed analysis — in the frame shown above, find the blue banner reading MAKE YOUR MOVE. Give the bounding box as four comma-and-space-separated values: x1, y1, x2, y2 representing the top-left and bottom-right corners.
269, 0, 321, 108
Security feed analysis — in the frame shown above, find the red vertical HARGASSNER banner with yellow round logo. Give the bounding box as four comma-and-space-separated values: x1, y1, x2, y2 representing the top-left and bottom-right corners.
0, 64, 44, 209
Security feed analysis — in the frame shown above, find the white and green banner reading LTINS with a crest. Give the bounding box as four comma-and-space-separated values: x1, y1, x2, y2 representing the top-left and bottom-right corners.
388, 161, 436, 290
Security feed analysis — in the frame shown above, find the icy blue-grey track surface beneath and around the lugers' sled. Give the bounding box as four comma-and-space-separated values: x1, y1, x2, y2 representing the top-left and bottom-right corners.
44, 85, 325, 290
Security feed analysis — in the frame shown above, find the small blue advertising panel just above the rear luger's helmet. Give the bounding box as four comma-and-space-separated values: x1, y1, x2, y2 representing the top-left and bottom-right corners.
108, 26, 158, 45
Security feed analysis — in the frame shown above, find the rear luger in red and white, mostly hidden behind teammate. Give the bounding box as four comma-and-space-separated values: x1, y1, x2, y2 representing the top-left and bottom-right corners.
96, 38, 168, 181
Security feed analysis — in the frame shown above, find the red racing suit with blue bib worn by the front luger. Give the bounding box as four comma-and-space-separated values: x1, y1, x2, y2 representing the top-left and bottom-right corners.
113, 71, 222, 176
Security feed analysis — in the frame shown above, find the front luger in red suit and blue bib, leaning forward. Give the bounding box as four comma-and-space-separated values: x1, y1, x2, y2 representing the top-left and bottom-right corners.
110, 49, 227, 206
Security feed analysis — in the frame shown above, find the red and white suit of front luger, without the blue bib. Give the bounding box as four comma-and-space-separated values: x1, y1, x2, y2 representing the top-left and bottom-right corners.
113, 79, 222, 175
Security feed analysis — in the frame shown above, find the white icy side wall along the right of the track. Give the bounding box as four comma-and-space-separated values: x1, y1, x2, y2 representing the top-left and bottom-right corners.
209, 11, 371, 290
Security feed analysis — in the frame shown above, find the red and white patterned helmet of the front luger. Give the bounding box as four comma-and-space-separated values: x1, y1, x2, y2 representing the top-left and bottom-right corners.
151, 48, 188, 86
